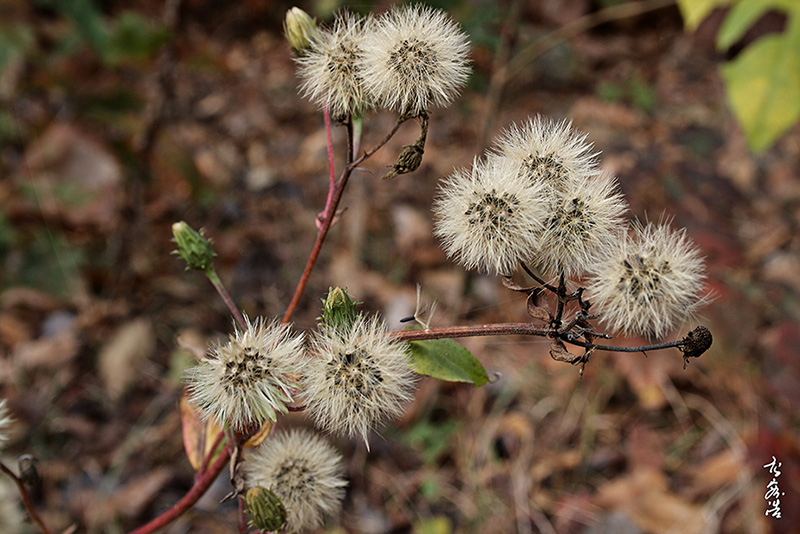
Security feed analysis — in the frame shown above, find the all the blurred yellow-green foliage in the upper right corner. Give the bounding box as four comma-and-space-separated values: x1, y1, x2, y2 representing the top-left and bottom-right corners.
678, 0, 800, 152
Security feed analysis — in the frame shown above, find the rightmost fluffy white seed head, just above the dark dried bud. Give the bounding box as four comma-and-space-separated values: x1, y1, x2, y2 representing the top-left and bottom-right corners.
588, 222, 706, 337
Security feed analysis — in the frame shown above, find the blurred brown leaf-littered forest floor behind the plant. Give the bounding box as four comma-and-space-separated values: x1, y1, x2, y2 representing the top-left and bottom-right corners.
0, 0, 800, 534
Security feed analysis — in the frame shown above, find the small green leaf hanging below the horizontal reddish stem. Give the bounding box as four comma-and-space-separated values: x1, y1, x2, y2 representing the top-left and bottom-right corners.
409, 339, 489, 386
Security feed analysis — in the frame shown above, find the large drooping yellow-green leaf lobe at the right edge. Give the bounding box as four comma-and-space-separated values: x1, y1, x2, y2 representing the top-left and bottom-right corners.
722, 30, 800, 152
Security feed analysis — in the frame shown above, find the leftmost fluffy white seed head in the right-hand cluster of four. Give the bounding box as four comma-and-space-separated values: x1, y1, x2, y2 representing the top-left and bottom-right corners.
433, 157, 547, 275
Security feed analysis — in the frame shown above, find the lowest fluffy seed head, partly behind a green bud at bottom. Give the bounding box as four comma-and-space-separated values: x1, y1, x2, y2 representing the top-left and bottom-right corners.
244, 429, 347, 532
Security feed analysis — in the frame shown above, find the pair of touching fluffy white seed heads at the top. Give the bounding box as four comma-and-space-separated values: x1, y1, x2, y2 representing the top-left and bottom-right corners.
297, 6, 470, 118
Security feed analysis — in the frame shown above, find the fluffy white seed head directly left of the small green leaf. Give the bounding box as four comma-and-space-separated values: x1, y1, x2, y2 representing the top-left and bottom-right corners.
301, 315, 418, 447
